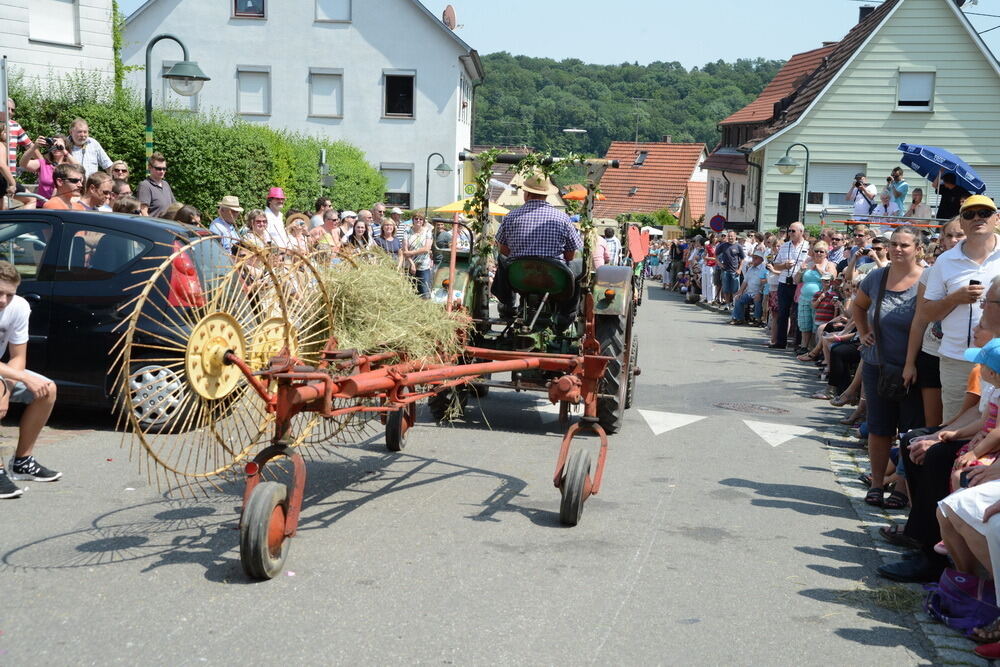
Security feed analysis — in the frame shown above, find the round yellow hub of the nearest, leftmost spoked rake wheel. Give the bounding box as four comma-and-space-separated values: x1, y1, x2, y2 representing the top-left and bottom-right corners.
184, 312, 246, 400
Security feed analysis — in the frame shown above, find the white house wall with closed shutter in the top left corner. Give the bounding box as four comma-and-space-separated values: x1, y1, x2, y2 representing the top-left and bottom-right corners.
0, 0, 114, 86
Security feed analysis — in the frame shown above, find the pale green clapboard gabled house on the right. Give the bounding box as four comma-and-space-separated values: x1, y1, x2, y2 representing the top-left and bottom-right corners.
740, 0, 1000, 227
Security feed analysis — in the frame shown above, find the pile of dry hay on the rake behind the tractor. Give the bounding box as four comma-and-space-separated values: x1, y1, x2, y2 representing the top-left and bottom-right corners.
321, 252, 471, 360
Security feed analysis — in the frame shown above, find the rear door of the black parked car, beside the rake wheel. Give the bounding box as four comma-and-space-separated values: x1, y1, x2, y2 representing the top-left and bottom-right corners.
49, 222, 153, 405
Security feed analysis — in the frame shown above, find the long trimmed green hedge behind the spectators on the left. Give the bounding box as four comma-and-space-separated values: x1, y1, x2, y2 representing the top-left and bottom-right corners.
9, 74, 385, 220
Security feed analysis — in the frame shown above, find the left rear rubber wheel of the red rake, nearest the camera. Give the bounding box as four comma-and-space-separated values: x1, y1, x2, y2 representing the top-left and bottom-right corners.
240, 482, 289, 579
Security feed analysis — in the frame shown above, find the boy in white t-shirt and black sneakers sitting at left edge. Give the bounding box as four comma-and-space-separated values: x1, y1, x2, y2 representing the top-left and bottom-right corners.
0, 261, 62, 498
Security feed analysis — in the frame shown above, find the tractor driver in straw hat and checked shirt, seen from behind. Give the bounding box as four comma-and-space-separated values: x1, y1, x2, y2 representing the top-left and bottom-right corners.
493, 170, 583, 326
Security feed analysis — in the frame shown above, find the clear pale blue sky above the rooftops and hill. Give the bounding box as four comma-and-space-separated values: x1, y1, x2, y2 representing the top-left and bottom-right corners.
119, 0, 1000, 68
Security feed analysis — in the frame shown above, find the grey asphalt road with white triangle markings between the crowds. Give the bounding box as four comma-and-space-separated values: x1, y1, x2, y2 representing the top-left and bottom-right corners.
0, 285, 934, 665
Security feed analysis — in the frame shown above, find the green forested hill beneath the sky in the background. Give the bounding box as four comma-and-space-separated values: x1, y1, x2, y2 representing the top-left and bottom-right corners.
475, 52, 784, 155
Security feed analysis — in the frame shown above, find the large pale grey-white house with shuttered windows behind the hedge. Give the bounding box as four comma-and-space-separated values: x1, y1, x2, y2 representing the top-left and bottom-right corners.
120, 0, 483, 208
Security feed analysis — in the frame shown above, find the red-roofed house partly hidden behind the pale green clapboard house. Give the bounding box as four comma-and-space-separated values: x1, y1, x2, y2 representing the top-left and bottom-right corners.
704, 43, 836, 229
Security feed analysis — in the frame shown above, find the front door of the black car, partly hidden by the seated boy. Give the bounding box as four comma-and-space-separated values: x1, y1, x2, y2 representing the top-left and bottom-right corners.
0, 217, 59, 375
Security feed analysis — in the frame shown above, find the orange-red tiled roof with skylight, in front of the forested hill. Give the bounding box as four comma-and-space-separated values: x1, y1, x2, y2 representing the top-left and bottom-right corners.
594, 141, 705, 218
